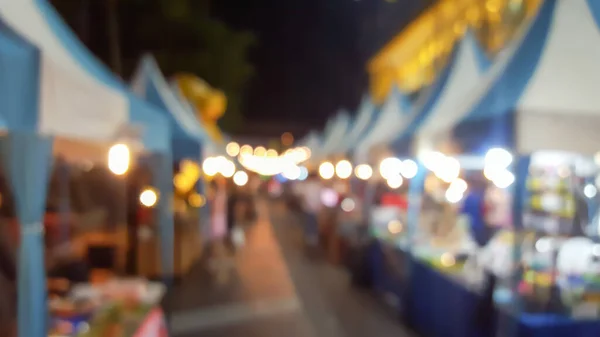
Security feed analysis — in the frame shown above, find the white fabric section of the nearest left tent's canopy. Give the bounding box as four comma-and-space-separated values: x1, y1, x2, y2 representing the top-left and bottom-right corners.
0, 0, 129, 141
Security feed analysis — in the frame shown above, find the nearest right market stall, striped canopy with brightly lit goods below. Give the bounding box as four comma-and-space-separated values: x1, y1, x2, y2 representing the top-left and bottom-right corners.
373, 0, 600, 336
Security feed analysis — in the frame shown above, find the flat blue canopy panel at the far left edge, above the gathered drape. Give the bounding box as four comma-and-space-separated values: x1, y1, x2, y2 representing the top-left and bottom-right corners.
0, 20, 40, 131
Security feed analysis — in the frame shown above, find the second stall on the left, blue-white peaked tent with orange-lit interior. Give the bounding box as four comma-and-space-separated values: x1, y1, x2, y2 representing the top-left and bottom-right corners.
132, 55, 212, 276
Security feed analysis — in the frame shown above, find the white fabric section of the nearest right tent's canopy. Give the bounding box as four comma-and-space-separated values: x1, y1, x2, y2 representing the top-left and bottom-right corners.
516, 0, 600, 154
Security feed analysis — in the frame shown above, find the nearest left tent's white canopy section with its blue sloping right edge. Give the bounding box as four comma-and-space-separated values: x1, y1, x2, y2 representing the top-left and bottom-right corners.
0, 0, 168, 151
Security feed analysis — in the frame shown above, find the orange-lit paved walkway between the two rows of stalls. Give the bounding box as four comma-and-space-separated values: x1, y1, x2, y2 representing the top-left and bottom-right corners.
168, 202, 411, 337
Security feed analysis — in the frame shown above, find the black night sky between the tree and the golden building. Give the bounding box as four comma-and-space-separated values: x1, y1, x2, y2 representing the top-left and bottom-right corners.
211, 0, 432, 127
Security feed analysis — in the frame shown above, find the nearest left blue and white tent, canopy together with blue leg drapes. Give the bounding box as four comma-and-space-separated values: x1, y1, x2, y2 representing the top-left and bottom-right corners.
0, 0, 173, 337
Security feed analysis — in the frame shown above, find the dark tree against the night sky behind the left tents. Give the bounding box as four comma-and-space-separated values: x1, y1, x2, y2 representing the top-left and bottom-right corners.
52, 0, 255, 131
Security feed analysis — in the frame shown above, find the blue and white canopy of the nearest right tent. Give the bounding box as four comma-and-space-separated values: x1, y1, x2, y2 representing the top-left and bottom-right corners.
428, 0, 600, 155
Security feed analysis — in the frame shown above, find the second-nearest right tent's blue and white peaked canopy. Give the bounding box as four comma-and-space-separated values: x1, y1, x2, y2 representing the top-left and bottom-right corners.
391, 32, 490, 156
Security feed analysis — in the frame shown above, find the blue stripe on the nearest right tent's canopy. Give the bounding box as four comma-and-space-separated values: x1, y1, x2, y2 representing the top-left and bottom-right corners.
454, 0, 556, 145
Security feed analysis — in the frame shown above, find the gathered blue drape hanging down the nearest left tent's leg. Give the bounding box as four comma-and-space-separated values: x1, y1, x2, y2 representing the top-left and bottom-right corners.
2, 132, 52, 337
